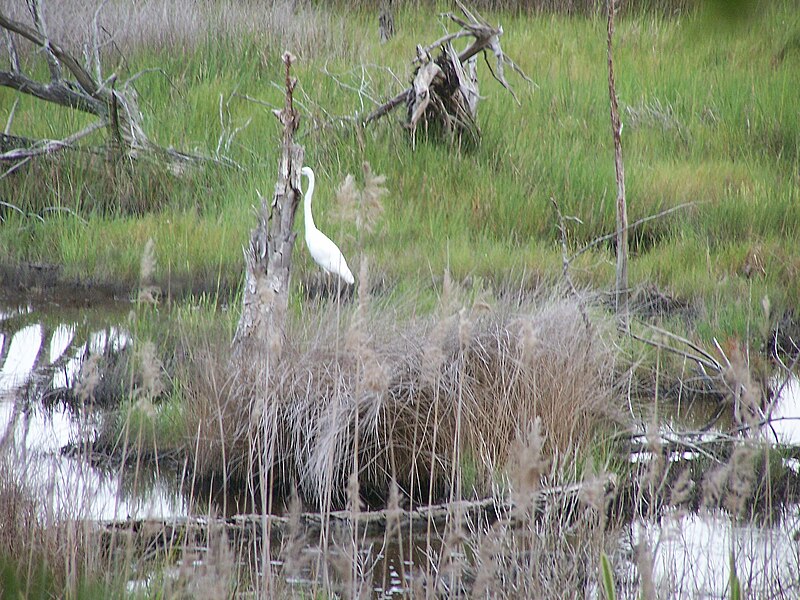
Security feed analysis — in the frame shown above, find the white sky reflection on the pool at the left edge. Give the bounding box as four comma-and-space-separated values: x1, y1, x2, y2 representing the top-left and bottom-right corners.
0, 309, 178, 519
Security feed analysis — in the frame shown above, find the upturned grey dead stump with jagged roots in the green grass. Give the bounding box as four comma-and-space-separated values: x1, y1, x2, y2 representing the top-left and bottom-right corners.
363, 0, 531, 145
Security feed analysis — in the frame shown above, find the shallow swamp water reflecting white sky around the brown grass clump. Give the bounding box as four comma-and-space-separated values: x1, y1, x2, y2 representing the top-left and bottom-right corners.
0, 292, 800, 598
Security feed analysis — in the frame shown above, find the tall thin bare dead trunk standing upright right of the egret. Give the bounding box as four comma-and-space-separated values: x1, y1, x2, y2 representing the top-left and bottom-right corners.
606, 0, 630, 333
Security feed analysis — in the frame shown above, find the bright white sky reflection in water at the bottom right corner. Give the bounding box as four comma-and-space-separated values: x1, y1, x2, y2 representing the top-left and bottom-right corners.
633, 506, 800, 598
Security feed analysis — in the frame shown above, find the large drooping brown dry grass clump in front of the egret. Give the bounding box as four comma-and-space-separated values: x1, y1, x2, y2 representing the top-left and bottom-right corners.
184, 288, 615, 509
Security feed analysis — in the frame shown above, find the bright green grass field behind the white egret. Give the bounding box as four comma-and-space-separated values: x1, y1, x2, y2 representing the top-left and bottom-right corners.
0, 2, 800, 346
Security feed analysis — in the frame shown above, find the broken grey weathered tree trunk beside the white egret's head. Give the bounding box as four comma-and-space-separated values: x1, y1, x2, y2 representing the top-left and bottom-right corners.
233, 52, 303, 368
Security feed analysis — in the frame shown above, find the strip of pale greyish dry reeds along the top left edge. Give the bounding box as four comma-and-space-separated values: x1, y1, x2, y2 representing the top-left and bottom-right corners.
7, 0, 357, 59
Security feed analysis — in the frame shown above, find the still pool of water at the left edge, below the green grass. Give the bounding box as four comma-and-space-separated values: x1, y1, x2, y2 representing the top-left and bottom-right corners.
0, 304, 187, 520
